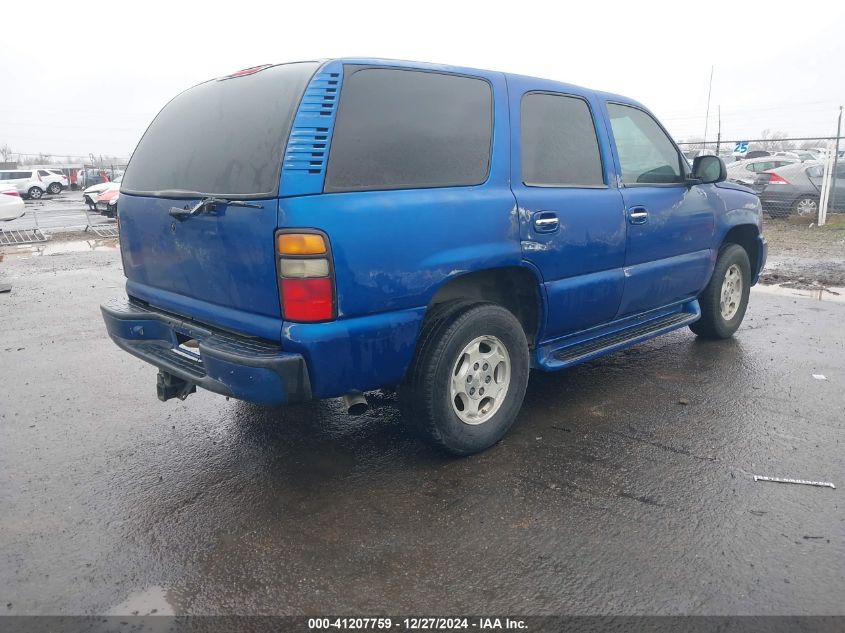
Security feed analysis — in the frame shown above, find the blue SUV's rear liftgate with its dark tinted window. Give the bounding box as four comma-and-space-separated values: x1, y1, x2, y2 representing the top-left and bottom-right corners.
119, 63, 317, 333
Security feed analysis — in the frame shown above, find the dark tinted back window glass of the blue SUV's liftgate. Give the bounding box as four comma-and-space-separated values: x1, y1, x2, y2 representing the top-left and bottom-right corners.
122, 62, 318, 198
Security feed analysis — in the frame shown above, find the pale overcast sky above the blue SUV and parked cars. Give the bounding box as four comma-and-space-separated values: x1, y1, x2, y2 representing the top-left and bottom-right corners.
0, 0, 845, 157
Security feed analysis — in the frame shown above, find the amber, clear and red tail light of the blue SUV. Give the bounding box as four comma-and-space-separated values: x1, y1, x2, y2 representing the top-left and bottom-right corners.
276, 230, 336, 323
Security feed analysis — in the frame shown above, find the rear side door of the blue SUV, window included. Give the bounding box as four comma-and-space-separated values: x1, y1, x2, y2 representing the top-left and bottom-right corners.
508, 77, 626, 339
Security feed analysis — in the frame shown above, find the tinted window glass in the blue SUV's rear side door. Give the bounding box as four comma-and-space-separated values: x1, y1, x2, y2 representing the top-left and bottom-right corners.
520, 92, 604, 187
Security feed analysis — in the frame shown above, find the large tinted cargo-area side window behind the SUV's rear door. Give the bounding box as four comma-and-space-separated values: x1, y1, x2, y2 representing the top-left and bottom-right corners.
325, 67, 493, 192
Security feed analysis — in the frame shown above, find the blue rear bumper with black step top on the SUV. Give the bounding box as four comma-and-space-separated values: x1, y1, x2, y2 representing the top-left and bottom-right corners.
100, 299, 312, 405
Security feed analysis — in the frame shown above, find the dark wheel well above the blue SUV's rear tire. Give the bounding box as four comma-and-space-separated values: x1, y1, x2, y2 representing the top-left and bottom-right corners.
428, 266, 540, 345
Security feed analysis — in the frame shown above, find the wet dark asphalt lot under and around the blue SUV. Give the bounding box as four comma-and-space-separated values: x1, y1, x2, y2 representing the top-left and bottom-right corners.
0, 248, 845, 615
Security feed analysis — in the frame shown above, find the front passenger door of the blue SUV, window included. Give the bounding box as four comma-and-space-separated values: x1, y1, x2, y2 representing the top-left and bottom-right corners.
607, 103, 717, 318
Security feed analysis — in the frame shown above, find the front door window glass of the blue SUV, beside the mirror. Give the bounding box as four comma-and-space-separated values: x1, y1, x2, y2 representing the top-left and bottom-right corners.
607, 103, 684, 185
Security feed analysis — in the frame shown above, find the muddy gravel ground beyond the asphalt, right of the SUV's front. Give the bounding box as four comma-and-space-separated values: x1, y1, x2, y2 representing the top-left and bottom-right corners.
760, 215, 845, 287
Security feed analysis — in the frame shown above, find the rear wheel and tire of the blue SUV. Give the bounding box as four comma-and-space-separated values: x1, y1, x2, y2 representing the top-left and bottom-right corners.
399, 301, 529, 455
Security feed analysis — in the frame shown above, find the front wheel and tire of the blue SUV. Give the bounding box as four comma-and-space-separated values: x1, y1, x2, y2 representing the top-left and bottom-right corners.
689, 244, 751, 339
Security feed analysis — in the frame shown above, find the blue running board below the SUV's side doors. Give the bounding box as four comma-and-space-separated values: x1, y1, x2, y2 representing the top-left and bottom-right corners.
538, 301, 701, 369
